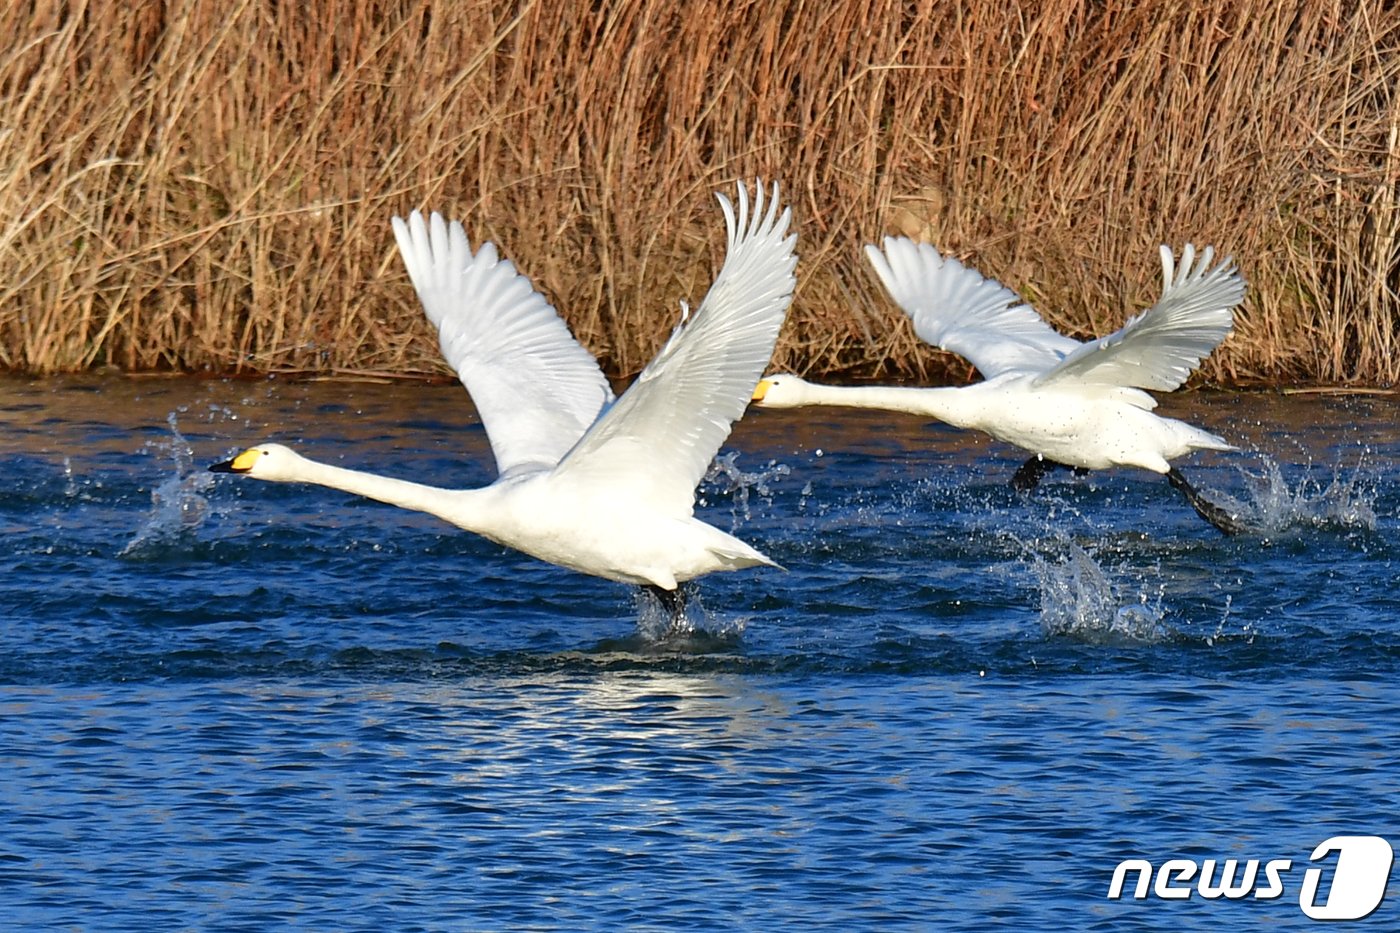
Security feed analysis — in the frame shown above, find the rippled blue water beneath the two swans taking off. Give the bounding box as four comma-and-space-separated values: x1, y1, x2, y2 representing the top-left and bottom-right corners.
0, 380, 1400, 930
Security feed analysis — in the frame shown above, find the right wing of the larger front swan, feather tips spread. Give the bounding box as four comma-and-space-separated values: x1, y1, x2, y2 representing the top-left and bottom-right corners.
556, 184, 797, 517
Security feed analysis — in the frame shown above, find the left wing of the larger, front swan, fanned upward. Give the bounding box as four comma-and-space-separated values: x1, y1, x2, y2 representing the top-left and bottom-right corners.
393, 210, 613, 476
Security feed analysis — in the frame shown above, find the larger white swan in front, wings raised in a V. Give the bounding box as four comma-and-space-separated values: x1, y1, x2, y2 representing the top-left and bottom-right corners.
210, 184, 797, 616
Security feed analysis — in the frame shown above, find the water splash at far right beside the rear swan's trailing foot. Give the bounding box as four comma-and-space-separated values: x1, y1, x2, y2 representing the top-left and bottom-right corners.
1212, 455, 1378, 535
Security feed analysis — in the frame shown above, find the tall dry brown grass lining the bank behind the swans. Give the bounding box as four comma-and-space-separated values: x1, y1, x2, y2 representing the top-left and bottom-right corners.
0, 0, 1400, 382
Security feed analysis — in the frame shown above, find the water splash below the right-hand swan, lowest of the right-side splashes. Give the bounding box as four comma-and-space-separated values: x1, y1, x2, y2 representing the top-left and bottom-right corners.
1030, 541, 1172, 644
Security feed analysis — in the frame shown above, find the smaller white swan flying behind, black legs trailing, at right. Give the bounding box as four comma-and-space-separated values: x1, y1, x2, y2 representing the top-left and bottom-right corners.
753, 237, 1245, 534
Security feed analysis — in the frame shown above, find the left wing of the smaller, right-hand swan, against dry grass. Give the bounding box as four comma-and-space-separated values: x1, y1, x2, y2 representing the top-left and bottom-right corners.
865, 237, 1079, 380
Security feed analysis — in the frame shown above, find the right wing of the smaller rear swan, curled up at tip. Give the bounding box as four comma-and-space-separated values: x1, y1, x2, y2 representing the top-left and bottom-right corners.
1036, 244, 1245, 391
